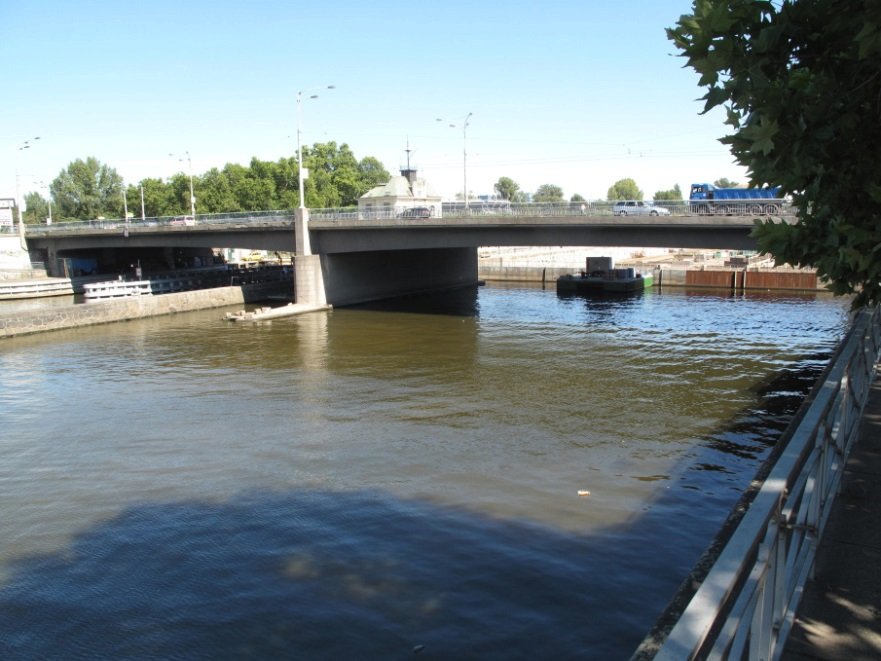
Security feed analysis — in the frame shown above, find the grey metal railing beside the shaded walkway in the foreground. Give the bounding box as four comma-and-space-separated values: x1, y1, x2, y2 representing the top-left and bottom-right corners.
637, 308, 881, 661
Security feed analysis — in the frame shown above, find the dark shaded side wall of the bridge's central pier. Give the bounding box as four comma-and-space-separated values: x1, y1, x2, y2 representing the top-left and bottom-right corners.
314, 248, 477, 306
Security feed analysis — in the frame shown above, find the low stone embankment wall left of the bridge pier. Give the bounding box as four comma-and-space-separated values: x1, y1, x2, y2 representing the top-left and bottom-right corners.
0, 283, 292, 338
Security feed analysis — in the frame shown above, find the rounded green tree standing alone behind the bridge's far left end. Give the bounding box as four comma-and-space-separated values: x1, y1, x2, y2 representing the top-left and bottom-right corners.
49, 156, 122, 220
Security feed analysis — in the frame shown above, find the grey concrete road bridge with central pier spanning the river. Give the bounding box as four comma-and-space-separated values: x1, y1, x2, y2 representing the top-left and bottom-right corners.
26, 203, 785, 305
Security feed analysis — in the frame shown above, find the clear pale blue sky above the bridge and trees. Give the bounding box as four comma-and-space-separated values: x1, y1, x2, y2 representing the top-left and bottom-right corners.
0, 0, 746, 205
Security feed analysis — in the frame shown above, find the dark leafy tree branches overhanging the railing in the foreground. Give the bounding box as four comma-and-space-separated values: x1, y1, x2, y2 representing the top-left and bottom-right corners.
667, 0, 881, 307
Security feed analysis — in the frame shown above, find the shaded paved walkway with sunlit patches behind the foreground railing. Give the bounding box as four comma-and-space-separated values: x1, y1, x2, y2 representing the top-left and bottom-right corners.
782, 370, 881, 661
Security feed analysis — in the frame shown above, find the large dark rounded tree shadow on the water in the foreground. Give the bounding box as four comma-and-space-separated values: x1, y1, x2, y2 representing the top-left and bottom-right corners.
0, 484, 672, 660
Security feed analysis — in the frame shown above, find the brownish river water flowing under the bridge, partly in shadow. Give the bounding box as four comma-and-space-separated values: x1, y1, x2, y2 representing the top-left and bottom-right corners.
0, 286, 847, 659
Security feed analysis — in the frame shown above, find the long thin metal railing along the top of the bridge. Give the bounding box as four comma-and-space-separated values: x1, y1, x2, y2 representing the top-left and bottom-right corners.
18, 200, 794, 236
